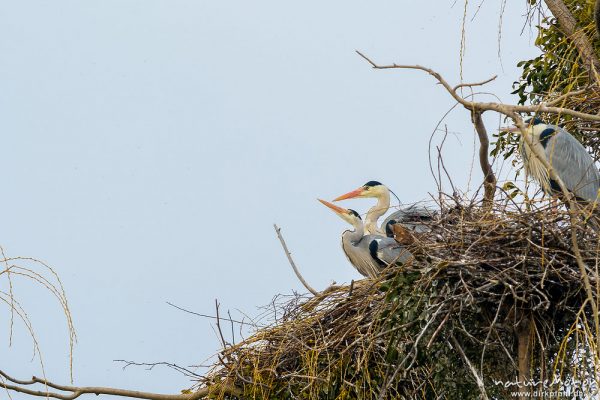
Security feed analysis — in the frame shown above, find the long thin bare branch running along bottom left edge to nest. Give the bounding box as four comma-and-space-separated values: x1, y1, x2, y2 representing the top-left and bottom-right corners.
0, 370, 242, 400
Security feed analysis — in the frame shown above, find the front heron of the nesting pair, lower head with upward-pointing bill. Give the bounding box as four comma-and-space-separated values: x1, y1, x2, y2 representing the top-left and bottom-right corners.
318, 199, 412, 278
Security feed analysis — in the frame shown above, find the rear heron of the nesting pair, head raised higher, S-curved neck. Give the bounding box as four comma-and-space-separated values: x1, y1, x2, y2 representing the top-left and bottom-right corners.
333, 181, 435, 236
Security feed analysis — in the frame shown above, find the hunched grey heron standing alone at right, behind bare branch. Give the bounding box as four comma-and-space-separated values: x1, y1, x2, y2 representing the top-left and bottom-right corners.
507, 118, 600, 202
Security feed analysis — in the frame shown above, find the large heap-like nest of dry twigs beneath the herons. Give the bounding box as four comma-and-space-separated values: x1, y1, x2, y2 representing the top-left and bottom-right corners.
200, 193, 598, 399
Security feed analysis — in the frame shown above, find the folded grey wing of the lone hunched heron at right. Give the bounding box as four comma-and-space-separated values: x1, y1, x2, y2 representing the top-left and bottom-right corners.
545, 128, 600, 201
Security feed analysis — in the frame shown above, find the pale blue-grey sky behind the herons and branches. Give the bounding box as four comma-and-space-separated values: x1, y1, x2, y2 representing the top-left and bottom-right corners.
0, 0, 537, 399
